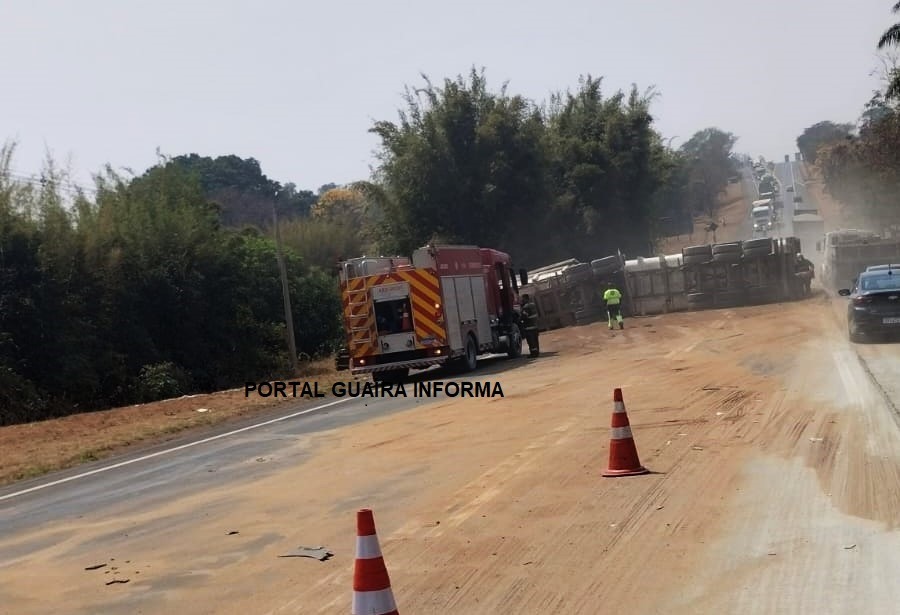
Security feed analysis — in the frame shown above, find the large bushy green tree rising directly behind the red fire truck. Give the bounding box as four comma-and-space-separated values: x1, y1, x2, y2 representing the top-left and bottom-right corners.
371, 68, 546, 264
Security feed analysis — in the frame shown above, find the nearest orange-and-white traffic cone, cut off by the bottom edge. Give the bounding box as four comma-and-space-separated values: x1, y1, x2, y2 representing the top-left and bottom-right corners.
352, 508, 398, 615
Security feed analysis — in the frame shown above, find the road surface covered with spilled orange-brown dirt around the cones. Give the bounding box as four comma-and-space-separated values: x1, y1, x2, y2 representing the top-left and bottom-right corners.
0, 295, 900, 615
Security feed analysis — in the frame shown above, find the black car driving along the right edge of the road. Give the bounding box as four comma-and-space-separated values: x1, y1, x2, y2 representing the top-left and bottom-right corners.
838, 269, 900, 342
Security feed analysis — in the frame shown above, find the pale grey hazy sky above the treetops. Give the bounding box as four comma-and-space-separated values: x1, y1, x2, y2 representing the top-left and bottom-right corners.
0, 0, 900, 189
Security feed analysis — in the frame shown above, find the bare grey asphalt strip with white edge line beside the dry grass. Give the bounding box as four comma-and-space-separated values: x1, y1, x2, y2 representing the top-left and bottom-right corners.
0, 357, 527, 536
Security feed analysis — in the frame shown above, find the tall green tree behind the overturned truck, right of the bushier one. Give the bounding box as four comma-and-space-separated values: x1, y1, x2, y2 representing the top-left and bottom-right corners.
546, 75, 663, 259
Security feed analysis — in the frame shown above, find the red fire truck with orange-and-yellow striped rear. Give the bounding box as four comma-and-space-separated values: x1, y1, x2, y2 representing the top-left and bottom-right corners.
339, 245, 528, 383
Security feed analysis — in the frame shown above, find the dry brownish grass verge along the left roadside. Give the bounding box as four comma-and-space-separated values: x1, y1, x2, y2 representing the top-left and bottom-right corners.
0, 359, 362, 485
